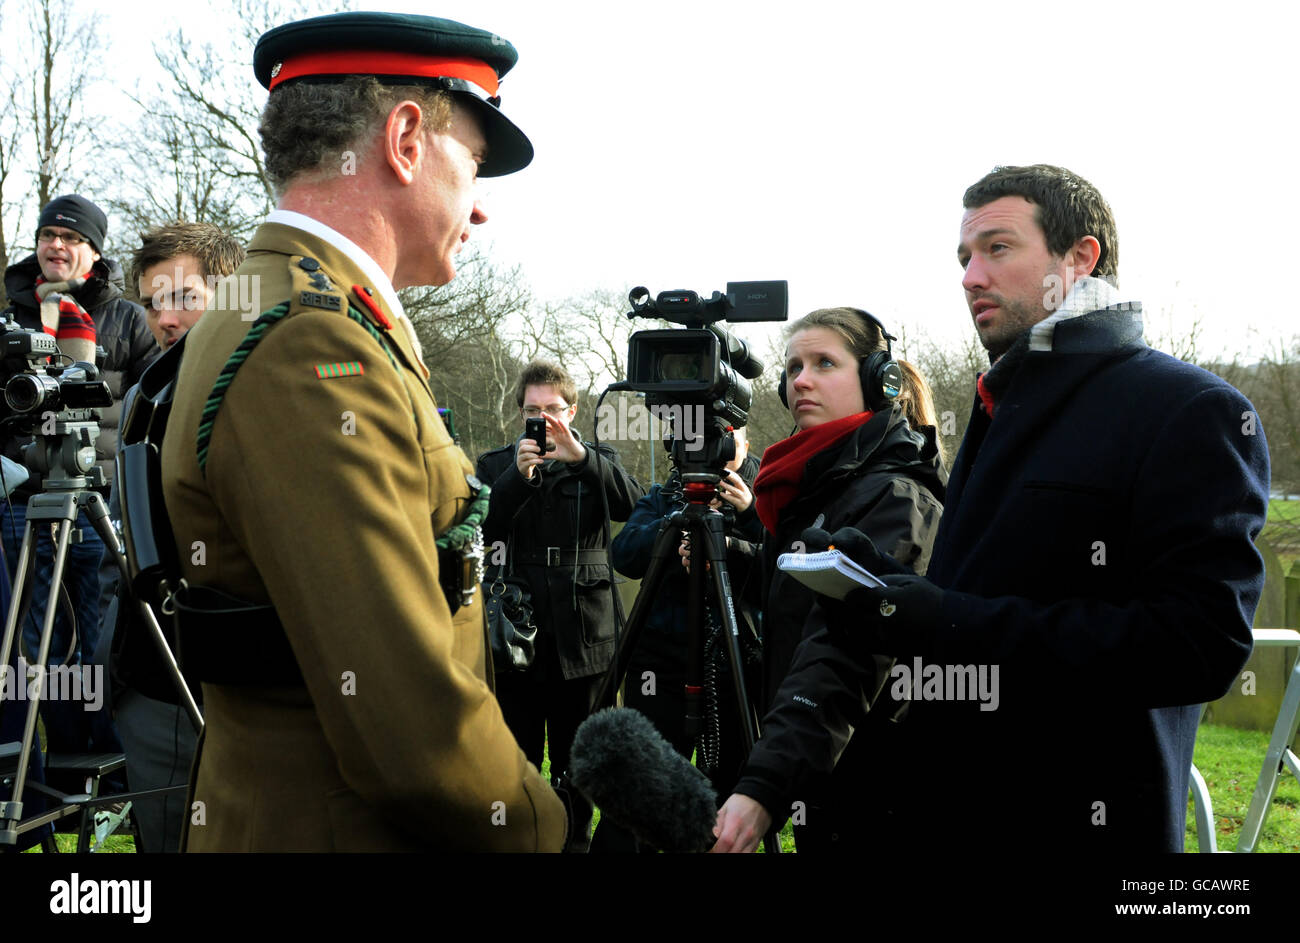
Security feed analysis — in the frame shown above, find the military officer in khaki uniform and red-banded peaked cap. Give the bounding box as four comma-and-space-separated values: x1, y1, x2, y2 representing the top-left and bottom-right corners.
163, 13, 567, 851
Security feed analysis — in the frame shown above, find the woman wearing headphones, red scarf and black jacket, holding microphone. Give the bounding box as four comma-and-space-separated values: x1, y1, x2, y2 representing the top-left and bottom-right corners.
719, 308, 948, 852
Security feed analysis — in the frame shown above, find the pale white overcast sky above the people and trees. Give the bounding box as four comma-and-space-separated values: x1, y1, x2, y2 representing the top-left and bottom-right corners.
86, 0, 1300, 361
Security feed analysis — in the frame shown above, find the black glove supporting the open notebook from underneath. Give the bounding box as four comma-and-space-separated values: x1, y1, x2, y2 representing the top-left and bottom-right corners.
816, 574, 944, 656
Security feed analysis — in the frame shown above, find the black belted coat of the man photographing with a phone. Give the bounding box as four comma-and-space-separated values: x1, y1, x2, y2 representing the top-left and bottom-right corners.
477, 442, 645, 679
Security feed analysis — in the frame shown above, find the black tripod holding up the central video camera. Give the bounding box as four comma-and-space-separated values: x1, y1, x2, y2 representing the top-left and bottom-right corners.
593, 471, 780, 853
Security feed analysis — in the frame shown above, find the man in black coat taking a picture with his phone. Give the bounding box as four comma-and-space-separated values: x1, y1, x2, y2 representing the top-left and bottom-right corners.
477, 360, 645, 849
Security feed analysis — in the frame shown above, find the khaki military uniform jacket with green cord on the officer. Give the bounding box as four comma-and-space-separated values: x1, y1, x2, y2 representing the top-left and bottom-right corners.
163, 224, 566, 852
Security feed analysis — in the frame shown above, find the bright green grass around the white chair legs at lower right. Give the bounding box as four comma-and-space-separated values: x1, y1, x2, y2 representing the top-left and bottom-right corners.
1186, 723, 1300, 853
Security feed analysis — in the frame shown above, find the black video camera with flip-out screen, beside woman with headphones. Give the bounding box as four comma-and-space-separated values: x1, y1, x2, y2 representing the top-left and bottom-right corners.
625, 281, 789, 476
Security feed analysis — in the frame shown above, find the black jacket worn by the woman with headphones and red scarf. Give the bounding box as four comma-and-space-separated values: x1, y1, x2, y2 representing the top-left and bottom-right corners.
736, 407, 948, 851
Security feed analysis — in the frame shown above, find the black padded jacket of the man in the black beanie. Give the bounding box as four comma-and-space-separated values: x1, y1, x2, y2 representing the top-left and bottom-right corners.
4, 254, 161, 502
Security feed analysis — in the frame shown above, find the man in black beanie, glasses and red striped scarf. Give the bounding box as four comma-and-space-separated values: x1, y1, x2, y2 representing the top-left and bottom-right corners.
0, 194, 159, 752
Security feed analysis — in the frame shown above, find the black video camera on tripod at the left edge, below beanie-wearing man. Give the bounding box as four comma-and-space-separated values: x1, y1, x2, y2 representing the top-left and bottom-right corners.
0, 320, 113, 488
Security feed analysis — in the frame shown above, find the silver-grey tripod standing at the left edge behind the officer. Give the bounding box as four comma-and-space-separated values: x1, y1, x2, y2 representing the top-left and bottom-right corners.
0, 410, 203, 849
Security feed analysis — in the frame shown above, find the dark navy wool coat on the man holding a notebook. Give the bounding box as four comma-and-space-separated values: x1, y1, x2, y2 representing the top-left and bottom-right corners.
754, 306, 1269, 855
